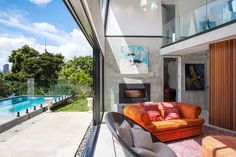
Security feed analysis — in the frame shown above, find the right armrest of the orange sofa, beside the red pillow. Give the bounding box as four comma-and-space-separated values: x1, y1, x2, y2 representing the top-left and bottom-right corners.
177, 103, 201, 119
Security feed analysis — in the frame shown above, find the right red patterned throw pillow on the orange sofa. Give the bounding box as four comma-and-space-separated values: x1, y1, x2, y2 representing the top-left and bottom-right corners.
161, 102, 180, 120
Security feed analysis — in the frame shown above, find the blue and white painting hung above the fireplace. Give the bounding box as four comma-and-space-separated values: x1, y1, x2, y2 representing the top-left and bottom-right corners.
119, 45, 148, 74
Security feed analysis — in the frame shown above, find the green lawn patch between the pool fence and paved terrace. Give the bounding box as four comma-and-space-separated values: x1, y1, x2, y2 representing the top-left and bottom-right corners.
55, 99, 89, 112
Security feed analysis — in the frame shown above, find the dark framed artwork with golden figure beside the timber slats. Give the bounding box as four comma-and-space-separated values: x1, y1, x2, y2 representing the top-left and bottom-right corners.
185, 64, 205, 91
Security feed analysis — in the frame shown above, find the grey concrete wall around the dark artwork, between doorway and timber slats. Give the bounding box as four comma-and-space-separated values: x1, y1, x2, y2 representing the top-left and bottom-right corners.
181, 52, 208, 109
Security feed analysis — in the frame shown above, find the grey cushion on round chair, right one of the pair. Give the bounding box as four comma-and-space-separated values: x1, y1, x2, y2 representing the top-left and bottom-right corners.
131, 128, 153, 150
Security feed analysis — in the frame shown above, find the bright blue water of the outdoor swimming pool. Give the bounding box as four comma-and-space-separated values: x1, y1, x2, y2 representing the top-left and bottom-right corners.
0, 96, 59, 115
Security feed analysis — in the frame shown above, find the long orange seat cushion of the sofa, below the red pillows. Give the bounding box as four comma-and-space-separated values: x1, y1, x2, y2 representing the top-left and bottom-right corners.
153, 118, 204, 132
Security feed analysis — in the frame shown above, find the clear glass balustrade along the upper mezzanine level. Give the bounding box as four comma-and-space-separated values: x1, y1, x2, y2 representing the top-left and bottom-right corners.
163, 0, 236, 45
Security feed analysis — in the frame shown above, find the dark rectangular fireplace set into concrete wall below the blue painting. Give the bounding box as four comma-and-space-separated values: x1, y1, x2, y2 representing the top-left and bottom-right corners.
119, 84, 150, 103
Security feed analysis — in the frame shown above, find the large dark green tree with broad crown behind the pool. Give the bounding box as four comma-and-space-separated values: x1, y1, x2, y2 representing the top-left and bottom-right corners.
5, 45, 64, 95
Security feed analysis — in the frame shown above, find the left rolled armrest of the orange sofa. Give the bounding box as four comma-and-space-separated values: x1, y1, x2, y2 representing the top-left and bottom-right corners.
123, 104, 151, 128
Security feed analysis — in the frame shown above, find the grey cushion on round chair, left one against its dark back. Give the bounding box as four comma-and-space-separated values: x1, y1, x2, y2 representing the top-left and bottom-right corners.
117, 120, 134, 147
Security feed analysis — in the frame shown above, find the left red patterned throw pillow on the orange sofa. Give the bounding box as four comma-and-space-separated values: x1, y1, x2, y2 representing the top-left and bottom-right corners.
142, 103, 163, 121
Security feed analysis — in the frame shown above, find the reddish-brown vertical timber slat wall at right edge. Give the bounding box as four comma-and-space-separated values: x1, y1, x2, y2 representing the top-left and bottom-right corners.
209, 39, 236, 130
